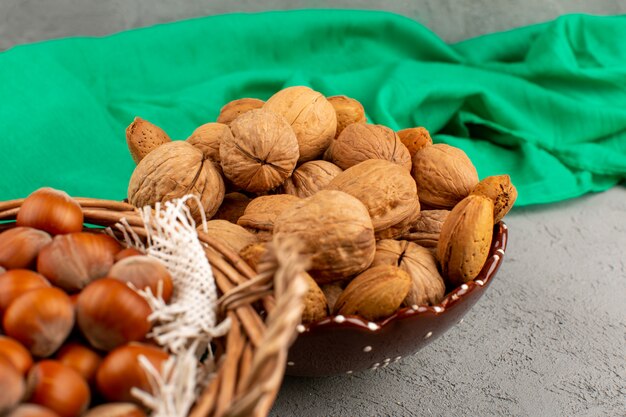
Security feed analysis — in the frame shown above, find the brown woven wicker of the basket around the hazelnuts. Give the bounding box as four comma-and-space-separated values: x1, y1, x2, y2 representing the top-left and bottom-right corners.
0, 198, 306, 417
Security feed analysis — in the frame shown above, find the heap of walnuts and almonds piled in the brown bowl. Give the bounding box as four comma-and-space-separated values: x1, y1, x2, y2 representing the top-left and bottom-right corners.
126, 86, 517, 323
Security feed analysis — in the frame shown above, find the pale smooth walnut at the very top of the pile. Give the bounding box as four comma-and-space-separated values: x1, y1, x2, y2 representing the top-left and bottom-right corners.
263, 86, 337, 162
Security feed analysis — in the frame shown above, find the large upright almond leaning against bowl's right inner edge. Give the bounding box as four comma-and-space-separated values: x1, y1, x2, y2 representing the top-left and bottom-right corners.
437, 195, 493, 287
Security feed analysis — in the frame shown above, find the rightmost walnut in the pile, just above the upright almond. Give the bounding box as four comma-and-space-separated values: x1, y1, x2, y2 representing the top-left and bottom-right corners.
411, 144, 478, 209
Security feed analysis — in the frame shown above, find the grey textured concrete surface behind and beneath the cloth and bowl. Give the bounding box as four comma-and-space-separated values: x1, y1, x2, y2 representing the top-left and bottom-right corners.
0, 0, 626, 417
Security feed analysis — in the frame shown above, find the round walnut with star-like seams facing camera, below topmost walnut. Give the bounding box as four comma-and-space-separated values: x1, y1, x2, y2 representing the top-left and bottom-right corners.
220, 109, 299, 192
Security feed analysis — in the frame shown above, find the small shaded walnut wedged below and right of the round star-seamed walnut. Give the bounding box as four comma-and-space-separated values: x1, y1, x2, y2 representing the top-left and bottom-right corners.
283, 160, 343, 198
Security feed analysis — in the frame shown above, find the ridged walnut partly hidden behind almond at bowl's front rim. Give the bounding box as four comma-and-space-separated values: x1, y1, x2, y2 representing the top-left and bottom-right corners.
372, 239, 446, 306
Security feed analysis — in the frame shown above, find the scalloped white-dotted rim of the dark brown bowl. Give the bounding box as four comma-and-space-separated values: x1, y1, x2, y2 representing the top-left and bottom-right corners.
297, 221, 508, 334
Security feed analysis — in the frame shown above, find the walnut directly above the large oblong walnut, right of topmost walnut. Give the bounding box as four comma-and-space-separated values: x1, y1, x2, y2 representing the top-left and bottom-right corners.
325, 123, 411, 171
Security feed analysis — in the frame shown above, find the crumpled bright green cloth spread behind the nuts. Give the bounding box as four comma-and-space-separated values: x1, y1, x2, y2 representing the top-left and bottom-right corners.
0, 10, 626, 205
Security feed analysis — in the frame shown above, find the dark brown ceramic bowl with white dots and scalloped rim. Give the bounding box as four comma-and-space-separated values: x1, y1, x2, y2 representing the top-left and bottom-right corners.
287, 222, 508, 376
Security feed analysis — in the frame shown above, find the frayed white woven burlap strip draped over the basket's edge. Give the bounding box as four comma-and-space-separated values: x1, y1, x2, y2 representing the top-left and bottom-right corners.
112, 195, 230, 417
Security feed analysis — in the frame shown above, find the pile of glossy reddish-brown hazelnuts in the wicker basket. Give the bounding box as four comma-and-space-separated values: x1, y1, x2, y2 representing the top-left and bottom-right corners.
0, 188, 173, 417
